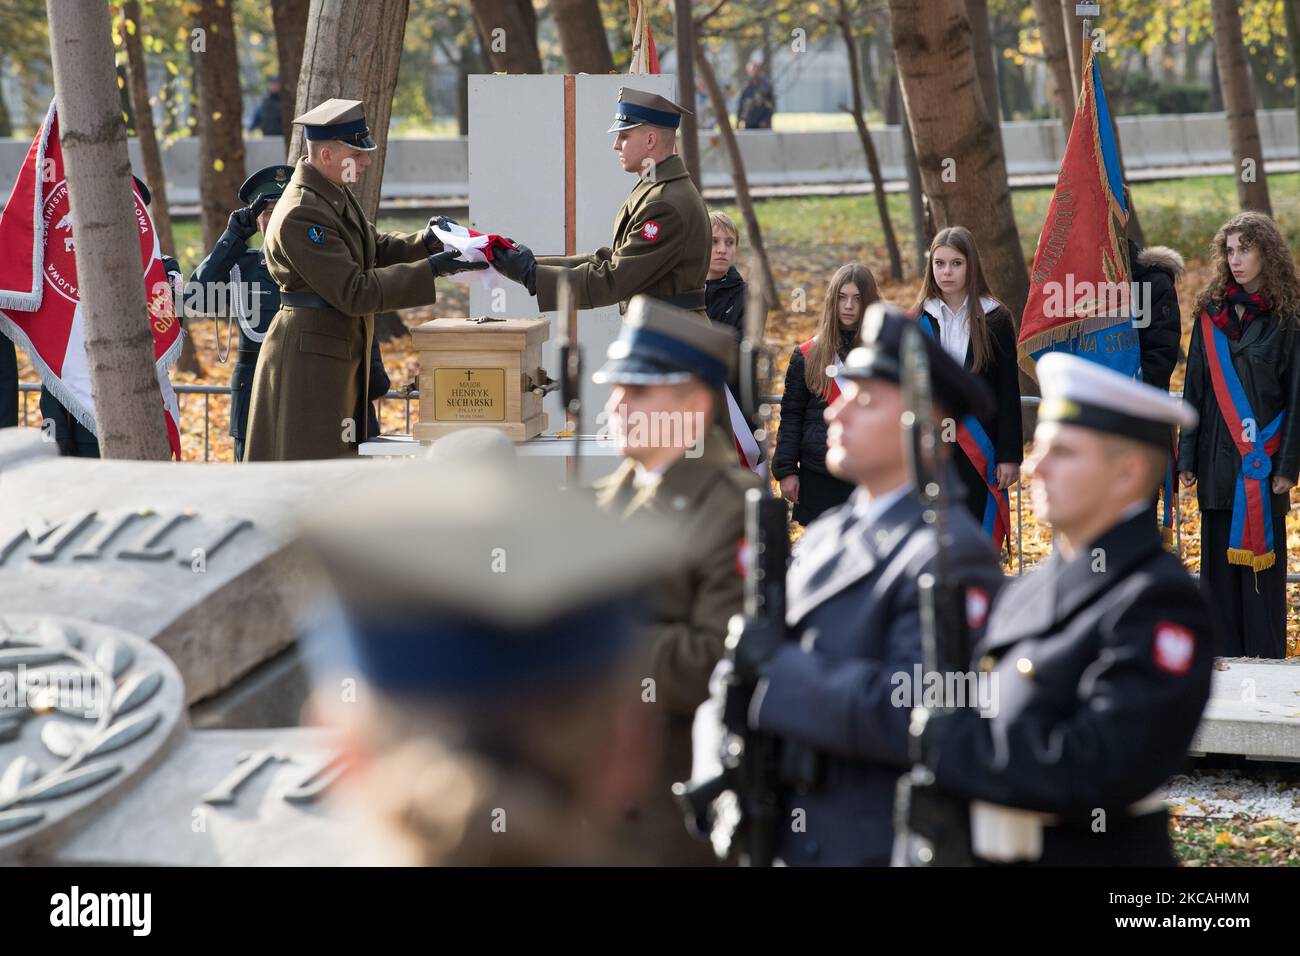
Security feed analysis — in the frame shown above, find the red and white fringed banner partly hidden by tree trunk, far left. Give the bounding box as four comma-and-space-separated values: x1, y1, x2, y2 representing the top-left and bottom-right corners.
0, 103, 182, 459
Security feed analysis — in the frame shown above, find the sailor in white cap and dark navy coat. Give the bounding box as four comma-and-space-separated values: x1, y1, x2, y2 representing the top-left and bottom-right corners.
914, 352, 1213, 866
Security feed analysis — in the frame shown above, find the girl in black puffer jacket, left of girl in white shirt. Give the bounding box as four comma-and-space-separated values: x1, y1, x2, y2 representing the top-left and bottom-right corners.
772, 263, 880, 524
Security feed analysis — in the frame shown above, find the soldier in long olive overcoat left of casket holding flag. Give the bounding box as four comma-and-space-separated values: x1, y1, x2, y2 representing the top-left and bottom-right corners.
244, 99, 486, 462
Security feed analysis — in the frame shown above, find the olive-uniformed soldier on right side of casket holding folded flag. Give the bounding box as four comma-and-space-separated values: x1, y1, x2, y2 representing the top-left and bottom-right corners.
493, 87, 712, 321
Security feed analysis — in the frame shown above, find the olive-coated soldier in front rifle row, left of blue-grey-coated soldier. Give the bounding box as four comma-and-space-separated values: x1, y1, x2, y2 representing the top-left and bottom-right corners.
593, 295, 758, 866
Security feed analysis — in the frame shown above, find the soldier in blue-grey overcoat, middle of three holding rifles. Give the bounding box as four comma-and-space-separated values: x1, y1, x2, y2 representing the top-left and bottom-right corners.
749, 306, 1002, 866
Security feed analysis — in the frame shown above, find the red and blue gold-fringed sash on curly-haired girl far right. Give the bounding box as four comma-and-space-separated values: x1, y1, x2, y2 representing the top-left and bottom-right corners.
1201, 312, 1282, 571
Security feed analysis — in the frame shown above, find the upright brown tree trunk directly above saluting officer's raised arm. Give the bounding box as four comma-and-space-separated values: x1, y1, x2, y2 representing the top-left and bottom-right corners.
191, 0, 244, 248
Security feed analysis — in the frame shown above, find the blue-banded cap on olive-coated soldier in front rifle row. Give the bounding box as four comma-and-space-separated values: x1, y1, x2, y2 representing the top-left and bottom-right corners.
592, 295, 736, 390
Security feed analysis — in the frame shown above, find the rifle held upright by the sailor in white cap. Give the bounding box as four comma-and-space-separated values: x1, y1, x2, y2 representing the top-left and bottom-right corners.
894, 319, 972, 866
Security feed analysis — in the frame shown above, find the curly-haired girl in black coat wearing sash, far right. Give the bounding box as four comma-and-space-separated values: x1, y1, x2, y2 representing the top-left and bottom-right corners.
1178, 212, 1300, 658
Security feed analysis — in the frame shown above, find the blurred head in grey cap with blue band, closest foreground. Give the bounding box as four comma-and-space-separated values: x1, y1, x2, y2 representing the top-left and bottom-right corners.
304, 453, 671, 865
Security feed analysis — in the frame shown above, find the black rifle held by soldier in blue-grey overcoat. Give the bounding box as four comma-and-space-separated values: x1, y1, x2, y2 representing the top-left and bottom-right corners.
672, 256, 818, 866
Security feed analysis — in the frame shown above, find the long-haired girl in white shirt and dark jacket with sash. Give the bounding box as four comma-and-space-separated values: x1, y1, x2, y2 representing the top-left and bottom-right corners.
914, 226, 1024, 550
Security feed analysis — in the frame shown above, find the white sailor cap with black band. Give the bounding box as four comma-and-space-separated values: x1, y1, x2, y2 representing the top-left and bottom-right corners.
1037, 352, 1196, 449
